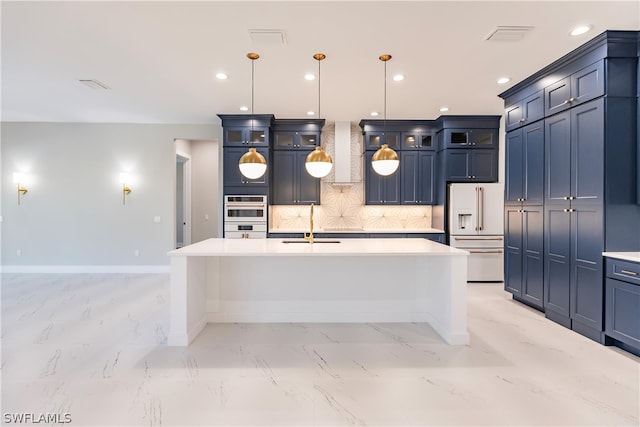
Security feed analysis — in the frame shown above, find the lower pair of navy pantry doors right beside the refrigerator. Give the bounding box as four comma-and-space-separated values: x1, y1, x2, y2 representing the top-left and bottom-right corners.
504, 205, 544, 309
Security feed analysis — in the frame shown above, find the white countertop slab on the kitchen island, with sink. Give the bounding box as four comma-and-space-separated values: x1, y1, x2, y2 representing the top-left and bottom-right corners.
168, 238, 469, 256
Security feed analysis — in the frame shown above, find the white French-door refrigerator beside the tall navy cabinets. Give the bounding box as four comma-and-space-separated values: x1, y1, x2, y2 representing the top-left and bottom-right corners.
448, 183, 504, 282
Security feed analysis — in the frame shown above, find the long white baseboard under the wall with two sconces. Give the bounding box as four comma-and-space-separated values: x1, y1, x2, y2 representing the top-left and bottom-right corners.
0, 265, 170, 274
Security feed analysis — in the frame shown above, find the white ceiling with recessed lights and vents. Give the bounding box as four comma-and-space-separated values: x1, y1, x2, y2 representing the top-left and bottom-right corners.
0, 0, 640, 123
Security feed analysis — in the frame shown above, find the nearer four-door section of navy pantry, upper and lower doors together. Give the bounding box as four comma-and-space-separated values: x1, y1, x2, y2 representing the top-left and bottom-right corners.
545, 98, 605, 341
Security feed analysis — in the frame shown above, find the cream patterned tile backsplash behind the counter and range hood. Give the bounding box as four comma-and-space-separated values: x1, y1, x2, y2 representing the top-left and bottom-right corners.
269, 123, 431, 232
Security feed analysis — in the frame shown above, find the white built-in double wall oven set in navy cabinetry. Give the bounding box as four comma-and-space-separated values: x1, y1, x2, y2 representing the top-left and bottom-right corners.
224, 195, 267, 239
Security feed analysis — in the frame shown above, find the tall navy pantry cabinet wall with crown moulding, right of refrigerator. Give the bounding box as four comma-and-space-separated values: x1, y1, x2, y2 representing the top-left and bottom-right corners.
499, 31, 640, 343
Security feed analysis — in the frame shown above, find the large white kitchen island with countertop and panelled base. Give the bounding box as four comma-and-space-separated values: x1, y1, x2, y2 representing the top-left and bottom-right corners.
168, 238, 469, 346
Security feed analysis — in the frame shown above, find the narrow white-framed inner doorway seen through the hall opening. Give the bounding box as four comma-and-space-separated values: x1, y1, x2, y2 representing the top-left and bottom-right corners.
175, 152, 191, 249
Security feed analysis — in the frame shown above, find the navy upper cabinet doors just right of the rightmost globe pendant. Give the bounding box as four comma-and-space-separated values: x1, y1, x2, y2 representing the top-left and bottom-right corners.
400, 150, 436, 205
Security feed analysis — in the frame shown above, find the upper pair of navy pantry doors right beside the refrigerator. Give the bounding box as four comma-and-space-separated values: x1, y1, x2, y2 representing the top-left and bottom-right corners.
505, 121, 544, 206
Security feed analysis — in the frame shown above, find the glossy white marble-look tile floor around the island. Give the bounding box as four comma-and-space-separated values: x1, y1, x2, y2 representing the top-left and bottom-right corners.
0, 274, 640, 426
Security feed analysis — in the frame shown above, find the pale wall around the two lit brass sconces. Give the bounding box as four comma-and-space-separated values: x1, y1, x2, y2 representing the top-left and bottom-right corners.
1, 123, 221, 266
